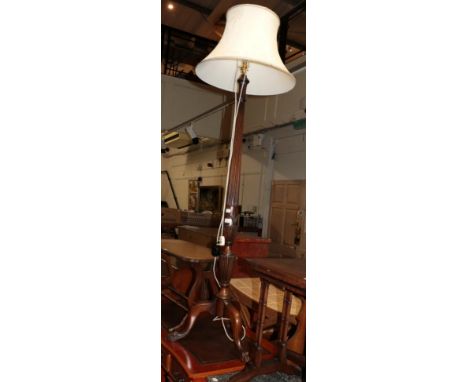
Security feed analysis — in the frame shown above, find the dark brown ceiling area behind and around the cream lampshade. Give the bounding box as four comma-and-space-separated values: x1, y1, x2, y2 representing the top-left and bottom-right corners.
161, 0, 306, 78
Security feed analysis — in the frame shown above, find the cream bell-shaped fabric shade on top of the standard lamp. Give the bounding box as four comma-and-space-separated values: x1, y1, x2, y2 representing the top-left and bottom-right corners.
195, 4, 296, 95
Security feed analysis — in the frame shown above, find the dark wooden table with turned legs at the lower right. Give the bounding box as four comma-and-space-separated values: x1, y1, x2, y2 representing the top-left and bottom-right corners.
230, 258, 306, 382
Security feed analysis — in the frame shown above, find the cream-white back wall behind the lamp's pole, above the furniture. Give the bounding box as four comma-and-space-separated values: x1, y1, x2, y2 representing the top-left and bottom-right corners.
161, 70, 306, 227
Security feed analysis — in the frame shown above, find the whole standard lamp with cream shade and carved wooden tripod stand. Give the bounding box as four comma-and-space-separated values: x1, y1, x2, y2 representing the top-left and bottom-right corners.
166, 4, 296, 361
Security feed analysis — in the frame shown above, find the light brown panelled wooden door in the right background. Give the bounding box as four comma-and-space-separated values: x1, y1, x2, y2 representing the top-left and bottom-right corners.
269, 180, 306, 257
